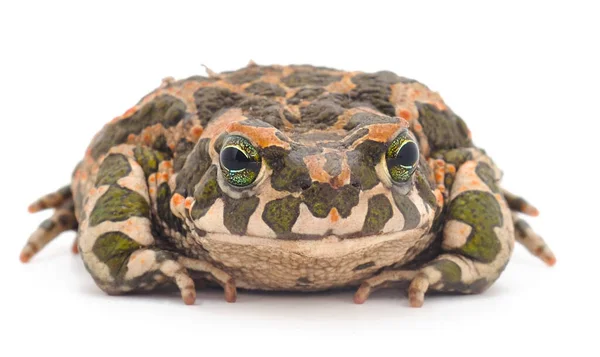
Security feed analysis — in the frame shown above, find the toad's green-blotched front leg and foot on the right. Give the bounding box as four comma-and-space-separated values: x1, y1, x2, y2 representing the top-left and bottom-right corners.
354, 151, 514, 307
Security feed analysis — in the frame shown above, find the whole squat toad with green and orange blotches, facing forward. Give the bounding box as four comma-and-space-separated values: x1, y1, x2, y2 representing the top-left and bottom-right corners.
21, 64, 554, 306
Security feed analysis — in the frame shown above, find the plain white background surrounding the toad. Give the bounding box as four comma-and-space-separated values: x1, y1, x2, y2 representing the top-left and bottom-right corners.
0, 0, 600, 357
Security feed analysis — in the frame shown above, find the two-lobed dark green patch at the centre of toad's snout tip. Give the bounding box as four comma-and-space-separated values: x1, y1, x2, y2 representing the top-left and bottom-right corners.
302, 182, 360, 218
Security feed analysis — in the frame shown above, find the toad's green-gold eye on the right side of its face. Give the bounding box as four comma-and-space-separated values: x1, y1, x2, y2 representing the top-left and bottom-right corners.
385, 131, 419, 183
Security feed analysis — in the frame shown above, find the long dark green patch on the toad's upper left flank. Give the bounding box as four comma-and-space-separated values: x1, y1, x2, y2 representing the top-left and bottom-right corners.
91, 95, 186, 159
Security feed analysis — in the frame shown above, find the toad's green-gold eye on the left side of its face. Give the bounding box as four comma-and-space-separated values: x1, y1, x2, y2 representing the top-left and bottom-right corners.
219, 135, 262, 187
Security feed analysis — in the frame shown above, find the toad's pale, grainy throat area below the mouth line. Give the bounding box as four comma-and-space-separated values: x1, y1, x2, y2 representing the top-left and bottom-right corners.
199, 227, 433, 291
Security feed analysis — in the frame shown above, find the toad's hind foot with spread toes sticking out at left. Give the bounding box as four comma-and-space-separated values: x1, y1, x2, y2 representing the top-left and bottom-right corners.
20, 195, 77, 263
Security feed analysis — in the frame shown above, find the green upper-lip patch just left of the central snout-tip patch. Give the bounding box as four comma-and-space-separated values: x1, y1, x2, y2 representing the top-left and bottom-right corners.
262, 195, 302, 234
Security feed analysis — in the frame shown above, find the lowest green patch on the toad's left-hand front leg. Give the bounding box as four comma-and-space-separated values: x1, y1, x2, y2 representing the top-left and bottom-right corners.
92, 232, 142, 277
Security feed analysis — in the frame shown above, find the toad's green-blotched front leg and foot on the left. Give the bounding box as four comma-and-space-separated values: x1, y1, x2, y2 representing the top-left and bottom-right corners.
79, 145, 236, 304
